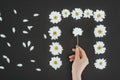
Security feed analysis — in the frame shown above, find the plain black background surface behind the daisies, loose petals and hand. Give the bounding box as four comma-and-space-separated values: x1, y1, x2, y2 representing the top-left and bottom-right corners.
0, 0, 120, 80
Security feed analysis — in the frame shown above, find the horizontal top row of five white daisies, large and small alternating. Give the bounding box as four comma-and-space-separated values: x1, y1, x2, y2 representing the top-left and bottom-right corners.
49, 8, 106, 24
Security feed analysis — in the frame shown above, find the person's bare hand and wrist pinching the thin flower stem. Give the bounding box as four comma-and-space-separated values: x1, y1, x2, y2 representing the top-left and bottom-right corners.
69, 46, 89, 80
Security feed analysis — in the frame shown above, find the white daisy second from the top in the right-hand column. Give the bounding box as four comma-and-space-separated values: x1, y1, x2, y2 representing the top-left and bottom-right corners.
94, 24, 107, 37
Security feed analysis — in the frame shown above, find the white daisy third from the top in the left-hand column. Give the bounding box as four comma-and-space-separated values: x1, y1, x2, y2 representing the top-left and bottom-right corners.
49, 42, 63, 55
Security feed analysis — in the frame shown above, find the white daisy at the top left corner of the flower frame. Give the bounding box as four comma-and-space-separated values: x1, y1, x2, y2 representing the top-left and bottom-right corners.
49, 11, 62, 24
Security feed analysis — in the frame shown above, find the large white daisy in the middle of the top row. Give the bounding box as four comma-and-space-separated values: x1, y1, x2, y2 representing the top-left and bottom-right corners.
71, 8, 83, 20
